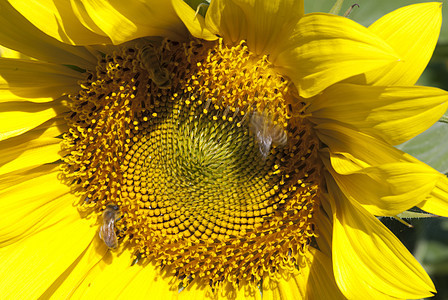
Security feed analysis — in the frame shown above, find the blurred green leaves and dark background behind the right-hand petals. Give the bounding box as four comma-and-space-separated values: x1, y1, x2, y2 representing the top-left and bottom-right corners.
305, 0, 448, 300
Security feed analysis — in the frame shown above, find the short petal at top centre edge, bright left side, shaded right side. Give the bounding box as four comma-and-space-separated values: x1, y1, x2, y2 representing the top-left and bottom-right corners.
205, 0, 247, 45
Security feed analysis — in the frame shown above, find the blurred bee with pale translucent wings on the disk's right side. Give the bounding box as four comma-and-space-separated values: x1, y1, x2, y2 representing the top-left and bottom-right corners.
249, 112, 288, 160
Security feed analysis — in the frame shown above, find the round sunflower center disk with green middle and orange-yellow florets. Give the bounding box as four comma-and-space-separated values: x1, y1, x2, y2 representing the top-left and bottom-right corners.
63, 41, 320, 284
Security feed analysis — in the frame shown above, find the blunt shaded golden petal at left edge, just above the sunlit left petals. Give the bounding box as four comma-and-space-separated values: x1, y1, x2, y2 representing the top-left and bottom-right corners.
0, 58, 85, 98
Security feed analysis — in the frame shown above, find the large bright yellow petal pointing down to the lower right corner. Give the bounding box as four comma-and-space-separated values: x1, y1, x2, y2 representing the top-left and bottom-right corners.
329, 184, 435, 299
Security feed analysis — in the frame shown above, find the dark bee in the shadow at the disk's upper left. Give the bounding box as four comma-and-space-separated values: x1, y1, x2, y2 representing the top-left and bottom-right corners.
140, 43, 171, 89
